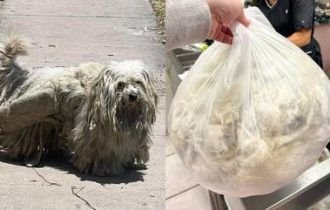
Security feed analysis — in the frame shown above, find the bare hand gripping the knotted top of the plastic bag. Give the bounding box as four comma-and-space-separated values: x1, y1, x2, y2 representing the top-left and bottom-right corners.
207, 0, 250, 44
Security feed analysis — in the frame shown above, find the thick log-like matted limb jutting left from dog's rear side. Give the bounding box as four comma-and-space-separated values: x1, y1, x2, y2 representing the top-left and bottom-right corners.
0, 89, 56, 134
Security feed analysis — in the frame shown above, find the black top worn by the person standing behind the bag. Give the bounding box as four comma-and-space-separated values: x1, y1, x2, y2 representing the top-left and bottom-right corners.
256, 0, 322, 68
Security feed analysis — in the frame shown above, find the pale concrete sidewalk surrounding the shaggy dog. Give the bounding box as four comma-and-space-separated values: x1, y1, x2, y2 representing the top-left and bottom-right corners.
0, 0, 166, 210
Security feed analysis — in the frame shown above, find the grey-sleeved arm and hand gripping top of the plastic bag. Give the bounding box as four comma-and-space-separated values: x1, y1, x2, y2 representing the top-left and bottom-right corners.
166, 0, 250, 50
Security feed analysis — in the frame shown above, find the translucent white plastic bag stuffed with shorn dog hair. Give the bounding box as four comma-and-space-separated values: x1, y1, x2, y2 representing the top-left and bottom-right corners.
169, 8, 330, 197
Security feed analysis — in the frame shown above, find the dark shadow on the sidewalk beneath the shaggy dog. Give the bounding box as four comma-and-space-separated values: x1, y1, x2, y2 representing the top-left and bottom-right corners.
0, 149, 146, 185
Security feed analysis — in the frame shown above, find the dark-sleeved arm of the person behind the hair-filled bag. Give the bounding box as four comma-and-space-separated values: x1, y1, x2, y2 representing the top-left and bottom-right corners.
288, 0, 314, 47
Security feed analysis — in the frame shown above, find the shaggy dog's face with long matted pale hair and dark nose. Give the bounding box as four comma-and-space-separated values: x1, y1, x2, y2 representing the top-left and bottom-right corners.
88, 61, 157, 131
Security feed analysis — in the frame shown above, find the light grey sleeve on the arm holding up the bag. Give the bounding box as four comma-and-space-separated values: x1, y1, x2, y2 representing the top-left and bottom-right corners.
166, 0, 211, 50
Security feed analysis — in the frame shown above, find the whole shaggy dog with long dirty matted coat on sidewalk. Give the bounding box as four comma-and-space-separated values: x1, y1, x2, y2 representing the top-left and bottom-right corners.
0, 35, 157, 176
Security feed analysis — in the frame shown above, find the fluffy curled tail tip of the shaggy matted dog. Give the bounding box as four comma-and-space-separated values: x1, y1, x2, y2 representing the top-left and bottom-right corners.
0, 33, 27, 66
